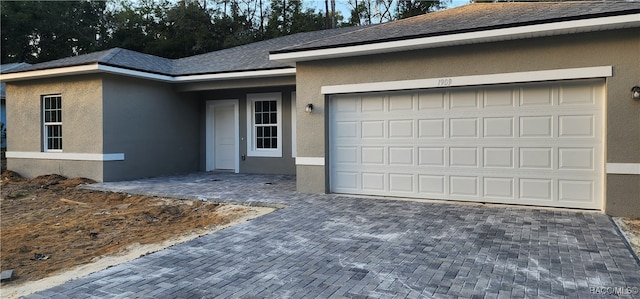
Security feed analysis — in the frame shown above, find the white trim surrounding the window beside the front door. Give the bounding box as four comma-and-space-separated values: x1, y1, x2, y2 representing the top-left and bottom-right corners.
247, 92, 283, 158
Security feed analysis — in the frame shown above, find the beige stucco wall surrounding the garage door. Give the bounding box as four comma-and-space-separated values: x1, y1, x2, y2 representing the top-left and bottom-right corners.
296, 28, 640, 216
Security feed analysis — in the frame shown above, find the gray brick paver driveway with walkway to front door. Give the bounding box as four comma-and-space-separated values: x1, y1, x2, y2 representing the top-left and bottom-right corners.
29, 173, 640, 298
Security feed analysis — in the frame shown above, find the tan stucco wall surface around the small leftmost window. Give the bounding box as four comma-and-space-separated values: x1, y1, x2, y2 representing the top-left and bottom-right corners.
7, 75, 103, 180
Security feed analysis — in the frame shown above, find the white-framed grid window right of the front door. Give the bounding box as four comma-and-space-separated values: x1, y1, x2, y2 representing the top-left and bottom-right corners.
247, 93, 282, 157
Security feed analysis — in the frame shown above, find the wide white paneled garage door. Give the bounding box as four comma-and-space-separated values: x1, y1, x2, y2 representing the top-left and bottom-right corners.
329, 80, 604, 209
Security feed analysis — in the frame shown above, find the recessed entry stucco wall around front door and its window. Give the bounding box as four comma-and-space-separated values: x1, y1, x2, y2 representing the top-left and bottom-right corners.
196, 86, 296, 175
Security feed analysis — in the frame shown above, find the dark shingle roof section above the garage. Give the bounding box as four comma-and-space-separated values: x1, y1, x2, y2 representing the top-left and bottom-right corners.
272, 1, 640, 53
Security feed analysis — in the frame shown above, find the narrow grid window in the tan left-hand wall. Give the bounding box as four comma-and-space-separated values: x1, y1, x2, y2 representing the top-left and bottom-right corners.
42, 95, 62, 152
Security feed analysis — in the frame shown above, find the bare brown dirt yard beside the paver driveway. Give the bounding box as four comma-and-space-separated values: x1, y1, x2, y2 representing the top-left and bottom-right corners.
0, 171, 271, 297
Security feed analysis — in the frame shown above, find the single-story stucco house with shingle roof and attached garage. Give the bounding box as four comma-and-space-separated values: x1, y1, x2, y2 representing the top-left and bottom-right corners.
2, 2, 640, 217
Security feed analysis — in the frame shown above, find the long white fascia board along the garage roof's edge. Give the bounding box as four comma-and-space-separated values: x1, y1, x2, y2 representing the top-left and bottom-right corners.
269, 14, 640, 63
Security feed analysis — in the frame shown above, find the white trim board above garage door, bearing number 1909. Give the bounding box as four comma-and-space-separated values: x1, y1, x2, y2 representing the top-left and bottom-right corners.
320, 66, 613, 94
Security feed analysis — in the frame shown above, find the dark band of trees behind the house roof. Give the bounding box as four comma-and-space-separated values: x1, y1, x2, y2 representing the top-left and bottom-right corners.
0, 0, 449, 64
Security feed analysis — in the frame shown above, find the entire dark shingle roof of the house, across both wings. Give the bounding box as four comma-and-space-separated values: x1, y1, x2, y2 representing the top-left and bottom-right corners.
1, 1, 640, 76
